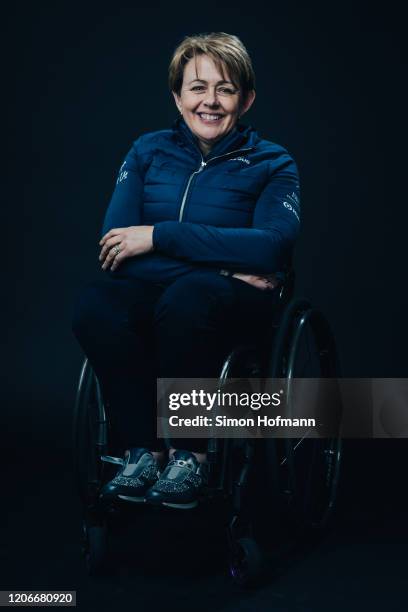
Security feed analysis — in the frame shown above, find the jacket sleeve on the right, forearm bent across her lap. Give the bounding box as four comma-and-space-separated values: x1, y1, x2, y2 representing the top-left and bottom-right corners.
153, 155, 300, 274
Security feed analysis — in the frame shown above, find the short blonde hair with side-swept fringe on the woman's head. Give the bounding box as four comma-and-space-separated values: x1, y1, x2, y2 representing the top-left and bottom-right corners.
169, 32, 255, 99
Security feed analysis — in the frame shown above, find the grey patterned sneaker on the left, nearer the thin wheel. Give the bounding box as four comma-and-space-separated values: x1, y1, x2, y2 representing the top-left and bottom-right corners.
99, 448, 160, 502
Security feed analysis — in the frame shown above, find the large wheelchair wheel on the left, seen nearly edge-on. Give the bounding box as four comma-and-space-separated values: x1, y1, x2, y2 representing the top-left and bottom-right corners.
73, 359, 107, 508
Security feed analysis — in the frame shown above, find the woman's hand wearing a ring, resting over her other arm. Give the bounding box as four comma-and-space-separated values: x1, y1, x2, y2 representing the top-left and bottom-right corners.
99, 225, 153, 272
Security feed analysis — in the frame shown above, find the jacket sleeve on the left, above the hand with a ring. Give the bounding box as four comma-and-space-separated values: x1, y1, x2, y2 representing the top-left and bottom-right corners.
102, 138, 143, 235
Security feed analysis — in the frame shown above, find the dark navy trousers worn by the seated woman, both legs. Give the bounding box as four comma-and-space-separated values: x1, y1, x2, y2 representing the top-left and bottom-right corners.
73, 270, 277, 451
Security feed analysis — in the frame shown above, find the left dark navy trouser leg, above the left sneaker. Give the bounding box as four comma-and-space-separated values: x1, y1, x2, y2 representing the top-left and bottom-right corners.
73, 279, 164, 450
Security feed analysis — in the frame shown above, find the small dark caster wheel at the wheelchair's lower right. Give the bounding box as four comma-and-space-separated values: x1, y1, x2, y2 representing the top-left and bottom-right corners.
229, 538, 262, 587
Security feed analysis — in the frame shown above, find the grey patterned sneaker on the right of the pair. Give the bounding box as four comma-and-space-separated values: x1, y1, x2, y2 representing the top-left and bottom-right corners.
146, 450, 208, 510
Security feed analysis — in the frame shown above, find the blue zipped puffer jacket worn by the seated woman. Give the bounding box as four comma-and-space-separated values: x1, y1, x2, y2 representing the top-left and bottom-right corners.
102, 118, 299, 283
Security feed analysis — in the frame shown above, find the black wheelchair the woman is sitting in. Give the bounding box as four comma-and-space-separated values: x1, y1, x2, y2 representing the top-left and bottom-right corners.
73, 270, 342, 587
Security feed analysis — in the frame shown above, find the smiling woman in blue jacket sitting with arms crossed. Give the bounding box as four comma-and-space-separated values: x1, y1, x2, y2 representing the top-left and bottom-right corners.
73, 32, 299, 509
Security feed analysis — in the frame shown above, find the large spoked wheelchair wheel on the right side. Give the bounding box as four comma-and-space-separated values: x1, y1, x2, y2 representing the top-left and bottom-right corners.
267, 300, 342, 528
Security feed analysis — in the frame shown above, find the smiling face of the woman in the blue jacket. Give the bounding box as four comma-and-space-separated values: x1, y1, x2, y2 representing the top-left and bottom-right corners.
173, 55, 255, 153
